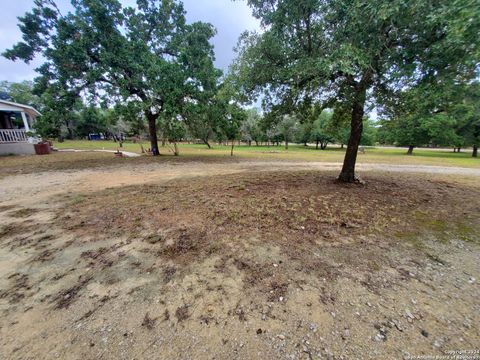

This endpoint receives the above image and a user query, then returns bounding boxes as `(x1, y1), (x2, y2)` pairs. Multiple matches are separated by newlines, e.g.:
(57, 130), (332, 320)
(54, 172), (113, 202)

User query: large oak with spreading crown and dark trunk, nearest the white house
(4, 0), (218, 155)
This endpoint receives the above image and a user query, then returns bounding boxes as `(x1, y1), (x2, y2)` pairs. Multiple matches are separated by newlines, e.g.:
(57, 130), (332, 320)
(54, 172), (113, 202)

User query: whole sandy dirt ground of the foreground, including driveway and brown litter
(0, 161), (480, 359)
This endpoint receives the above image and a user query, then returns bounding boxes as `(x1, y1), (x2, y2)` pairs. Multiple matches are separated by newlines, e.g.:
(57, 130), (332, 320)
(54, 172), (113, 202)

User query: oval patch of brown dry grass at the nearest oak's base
(60, 171), (478, 240)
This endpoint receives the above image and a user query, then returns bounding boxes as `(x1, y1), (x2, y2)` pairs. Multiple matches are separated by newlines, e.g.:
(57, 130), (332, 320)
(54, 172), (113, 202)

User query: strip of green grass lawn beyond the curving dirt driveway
(54, 140), (480, 168)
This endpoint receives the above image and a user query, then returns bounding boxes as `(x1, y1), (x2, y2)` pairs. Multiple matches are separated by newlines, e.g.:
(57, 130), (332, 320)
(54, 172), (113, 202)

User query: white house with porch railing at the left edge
(0, 100), (40, 155)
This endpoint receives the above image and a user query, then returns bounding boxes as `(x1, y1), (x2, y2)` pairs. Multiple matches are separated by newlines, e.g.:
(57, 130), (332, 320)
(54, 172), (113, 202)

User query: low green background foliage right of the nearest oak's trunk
(380, 79), (480, 156)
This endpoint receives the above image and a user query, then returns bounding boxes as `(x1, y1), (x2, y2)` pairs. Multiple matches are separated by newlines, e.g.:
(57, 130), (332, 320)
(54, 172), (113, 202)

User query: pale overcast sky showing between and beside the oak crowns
(0, 0), (259, 81)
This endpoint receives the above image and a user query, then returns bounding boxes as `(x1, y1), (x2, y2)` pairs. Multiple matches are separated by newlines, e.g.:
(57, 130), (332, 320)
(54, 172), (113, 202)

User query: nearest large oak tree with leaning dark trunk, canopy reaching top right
(232, 0), (480, 182)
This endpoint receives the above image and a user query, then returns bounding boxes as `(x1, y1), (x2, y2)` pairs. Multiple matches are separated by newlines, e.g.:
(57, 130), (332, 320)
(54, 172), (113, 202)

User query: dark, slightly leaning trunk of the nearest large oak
(338, 84), (367, 183)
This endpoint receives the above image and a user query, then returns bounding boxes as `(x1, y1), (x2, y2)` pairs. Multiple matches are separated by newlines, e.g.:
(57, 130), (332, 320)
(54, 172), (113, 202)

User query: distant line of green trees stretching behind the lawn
(0, 77), (480, 157)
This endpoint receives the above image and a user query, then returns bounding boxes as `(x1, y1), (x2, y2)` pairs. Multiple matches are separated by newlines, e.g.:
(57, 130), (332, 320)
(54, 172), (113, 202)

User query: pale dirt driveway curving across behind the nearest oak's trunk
(0, 161), (480, 204)
